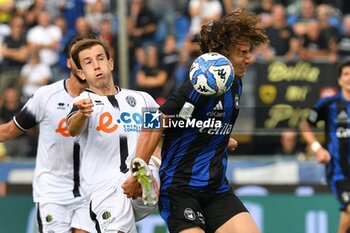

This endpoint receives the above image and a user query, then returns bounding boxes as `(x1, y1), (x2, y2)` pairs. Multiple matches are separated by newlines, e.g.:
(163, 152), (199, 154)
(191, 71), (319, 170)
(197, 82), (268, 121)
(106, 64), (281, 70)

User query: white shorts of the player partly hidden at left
(36, 199), (96, 233)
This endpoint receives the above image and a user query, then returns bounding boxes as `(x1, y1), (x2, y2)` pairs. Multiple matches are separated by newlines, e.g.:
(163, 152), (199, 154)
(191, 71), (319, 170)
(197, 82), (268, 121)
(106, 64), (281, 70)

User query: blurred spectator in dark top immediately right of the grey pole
(127, 0), (157, 46)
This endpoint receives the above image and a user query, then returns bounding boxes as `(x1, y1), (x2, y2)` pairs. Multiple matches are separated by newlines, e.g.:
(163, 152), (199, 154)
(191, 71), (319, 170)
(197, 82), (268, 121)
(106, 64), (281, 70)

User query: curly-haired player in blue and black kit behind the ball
(123, 10), (268, 233)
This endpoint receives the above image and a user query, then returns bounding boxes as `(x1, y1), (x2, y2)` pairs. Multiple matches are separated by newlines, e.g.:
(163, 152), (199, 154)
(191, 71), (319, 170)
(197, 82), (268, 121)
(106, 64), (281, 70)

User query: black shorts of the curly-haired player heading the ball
(159, 190), (248, 233)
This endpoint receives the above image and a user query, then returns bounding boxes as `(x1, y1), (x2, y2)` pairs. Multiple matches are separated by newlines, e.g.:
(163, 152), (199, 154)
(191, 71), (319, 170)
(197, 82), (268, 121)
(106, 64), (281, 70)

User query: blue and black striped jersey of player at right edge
(307, 93), (350, 181)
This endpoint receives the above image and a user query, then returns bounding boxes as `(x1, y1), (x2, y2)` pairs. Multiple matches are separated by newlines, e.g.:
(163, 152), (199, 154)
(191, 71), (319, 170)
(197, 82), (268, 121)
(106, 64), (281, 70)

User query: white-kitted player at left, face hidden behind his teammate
(0, 37), (96, 233)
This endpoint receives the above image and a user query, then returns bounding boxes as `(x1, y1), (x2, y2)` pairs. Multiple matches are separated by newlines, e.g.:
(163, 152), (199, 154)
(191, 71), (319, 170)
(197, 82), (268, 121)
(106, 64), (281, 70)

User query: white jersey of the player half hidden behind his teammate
(14, 80), (86, 204)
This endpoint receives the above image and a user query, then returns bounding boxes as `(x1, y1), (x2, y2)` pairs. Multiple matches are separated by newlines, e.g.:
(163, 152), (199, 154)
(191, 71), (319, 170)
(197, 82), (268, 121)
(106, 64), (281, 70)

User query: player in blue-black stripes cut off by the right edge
(300, 61), (350, 233)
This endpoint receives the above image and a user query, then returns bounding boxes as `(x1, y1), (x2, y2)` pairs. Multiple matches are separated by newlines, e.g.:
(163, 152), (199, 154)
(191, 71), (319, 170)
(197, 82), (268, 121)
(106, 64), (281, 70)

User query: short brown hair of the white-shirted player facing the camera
(72, 38), (110, 69)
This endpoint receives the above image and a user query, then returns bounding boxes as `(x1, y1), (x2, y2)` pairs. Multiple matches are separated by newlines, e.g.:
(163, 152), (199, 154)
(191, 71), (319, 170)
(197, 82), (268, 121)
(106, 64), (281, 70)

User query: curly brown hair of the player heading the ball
(199, 9), (269, 56)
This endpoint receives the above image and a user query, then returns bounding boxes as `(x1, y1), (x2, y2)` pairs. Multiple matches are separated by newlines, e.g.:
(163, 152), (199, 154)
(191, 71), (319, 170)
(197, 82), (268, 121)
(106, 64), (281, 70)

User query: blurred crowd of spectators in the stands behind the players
(0, 0), (350, 157)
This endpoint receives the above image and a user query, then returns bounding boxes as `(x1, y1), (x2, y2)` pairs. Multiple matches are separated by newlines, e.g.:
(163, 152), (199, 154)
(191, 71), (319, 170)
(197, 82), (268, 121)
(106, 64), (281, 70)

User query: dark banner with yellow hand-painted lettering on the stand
(254, 61), (338, 130)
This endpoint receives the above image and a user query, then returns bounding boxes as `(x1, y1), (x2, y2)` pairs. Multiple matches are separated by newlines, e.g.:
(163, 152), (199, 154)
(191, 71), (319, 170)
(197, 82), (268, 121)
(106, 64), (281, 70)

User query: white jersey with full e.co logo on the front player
(68, 89), (158, 199)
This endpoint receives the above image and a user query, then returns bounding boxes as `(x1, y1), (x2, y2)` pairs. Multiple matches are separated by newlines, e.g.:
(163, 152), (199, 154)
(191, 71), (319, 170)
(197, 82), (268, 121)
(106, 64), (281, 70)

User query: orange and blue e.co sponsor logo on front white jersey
(96, 112), (143, 133)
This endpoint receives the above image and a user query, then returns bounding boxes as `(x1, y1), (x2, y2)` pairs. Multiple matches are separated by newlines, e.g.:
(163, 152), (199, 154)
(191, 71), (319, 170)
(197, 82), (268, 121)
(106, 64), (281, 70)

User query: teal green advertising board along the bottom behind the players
(0, 194), (339, 233)
